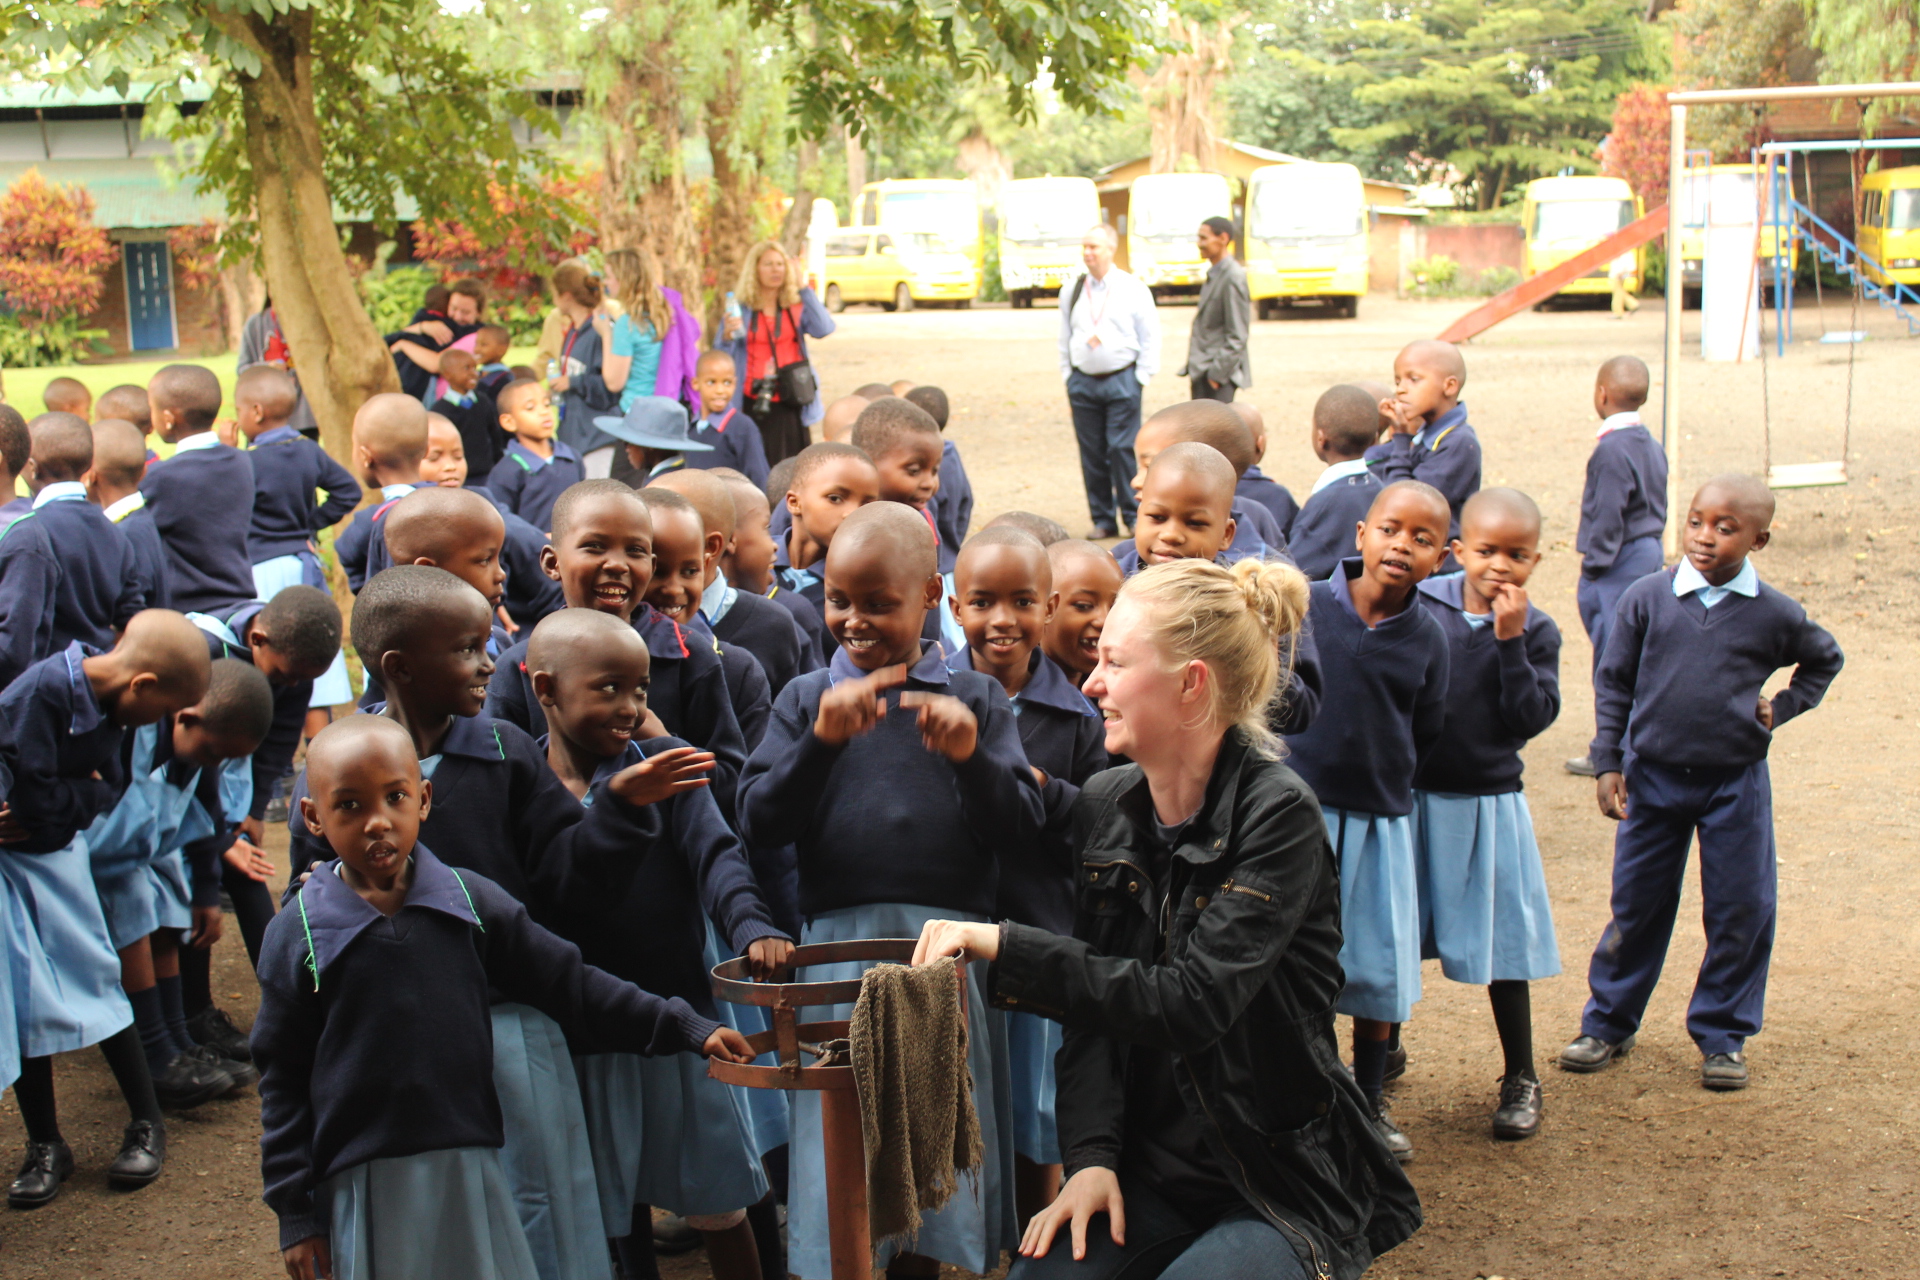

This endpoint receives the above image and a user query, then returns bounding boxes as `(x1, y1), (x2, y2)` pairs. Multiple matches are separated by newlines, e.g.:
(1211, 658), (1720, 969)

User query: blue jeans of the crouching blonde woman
(1006, 1176), (1308, 1280)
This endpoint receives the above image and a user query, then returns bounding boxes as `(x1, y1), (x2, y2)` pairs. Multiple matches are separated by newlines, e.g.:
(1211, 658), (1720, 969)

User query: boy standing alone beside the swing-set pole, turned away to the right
(1574, 355), (1667, 694)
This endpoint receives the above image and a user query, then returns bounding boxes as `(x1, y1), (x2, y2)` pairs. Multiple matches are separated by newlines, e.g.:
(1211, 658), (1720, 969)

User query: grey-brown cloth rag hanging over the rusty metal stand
(849, 956), (981, 1247)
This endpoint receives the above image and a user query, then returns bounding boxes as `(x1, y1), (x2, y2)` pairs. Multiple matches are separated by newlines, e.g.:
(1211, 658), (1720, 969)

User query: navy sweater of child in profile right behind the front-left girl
(286, 716), (660, 923)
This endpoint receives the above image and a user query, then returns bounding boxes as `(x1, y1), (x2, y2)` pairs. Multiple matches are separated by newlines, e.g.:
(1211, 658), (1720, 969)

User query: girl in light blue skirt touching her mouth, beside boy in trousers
(1413, 489), (1561, 1140)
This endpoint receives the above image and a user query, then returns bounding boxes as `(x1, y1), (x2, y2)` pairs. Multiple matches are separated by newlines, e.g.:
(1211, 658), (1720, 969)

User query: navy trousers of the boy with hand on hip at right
(1580, 756), (1778, 1054)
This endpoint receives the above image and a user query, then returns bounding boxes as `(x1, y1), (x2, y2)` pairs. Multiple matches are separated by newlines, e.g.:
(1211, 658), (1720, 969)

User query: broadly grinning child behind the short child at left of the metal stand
(486, 480), (747, 812)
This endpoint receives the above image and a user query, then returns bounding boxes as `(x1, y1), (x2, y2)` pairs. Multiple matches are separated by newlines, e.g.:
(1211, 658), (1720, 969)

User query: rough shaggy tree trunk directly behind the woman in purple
(601, 0), (701, 305)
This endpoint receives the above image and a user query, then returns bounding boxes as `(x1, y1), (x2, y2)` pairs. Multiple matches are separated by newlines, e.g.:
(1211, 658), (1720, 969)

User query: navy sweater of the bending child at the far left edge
(0, 641), (127, 854)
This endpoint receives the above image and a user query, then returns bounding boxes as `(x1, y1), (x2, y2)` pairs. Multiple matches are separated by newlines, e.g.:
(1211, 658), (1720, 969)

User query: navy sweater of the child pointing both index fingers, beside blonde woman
(739, 645), (1043, 917)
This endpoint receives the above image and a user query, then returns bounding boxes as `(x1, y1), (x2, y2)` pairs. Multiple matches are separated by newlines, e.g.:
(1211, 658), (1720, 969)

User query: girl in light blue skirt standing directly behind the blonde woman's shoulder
(1286, 480), (1448, 1159)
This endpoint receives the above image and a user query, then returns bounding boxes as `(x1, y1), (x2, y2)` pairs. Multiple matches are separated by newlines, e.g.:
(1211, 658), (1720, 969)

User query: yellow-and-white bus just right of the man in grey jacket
(1244, 161), (1367, 319)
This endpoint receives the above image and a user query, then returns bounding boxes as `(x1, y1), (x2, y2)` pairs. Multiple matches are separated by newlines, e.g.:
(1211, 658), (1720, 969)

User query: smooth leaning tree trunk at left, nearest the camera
(202, 4), (399, 461)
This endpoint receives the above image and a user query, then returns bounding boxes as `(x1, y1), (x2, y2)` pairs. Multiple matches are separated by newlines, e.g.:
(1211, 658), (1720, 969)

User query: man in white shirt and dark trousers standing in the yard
(1060, 223), (1160, 537)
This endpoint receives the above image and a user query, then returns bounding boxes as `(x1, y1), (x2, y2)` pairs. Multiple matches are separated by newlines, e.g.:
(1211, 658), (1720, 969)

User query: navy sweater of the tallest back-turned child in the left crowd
(140, 443), (253, 612)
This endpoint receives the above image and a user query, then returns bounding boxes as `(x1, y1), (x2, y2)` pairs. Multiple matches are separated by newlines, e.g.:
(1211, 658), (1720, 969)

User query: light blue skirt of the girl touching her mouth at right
(1413, 791), (1559, 986)
